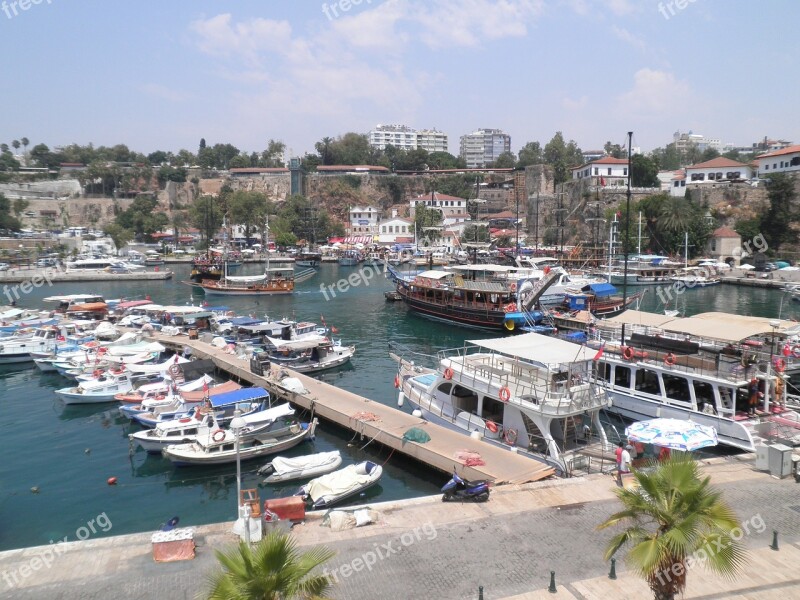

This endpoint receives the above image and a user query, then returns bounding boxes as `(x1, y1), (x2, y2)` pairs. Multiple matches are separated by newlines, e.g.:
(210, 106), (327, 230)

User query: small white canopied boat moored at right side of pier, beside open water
(261, 336), (356, 373)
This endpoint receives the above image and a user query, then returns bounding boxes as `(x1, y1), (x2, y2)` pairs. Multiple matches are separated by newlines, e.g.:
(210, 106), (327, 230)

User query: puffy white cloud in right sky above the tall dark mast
(617, 68), (692, 119)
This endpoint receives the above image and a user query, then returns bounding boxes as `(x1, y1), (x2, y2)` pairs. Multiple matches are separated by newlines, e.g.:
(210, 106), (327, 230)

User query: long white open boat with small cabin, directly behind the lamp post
(162, 416), (318, 467)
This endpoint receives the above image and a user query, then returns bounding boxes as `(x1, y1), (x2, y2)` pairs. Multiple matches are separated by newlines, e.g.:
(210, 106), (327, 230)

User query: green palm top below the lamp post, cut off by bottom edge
(208, 531), (335, 600)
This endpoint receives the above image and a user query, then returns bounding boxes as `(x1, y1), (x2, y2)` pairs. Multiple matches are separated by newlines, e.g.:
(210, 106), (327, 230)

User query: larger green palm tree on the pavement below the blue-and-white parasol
(598, 456), (745, 600)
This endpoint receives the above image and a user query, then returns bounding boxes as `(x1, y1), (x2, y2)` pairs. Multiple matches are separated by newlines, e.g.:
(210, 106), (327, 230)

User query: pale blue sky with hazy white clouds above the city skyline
(0, 0), (800, 156)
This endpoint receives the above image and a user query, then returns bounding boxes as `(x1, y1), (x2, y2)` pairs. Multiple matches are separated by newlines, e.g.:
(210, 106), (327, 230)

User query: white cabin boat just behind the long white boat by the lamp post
(128, 402), (294, 454)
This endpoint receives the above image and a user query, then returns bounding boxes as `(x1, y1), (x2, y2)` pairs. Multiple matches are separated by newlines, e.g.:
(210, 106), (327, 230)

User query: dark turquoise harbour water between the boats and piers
(0, 264), (800, 550)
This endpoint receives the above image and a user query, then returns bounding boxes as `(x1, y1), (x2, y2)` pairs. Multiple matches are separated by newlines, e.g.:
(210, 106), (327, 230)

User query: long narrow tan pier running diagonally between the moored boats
(152, 333), (555, 484)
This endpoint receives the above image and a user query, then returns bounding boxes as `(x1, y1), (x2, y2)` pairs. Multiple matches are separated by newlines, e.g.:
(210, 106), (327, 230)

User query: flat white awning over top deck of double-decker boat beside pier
(467, 333), (597, 366)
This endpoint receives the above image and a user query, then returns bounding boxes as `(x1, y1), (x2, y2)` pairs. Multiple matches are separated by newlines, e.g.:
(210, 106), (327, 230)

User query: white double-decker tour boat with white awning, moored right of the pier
(393, 333), (608, 473)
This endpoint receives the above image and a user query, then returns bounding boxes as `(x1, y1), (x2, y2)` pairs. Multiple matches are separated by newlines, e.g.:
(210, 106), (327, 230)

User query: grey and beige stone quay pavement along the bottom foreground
(0, 457), (800, 600)
